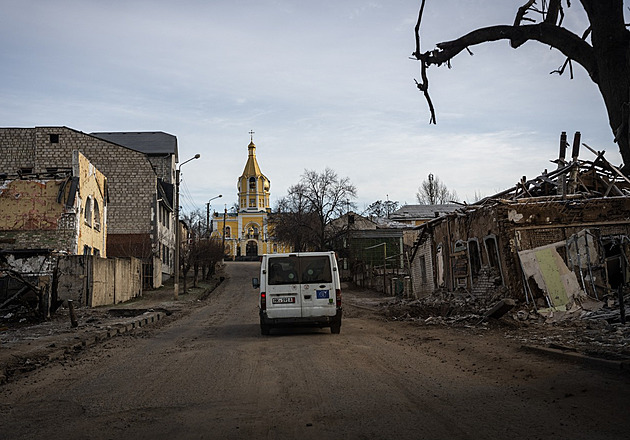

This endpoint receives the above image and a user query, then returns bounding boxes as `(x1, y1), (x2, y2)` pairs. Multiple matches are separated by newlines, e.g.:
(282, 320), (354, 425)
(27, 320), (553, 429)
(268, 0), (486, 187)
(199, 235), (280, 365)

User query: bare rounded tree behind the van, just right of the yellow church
(274, 168), (357, 250)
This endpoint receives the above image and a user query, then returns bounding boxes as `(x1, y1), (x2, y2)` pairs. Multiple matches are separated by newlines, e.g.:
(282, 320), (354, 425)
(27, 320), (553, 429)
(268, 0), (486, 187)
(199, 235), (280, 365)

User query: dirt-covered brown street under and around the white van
(0, 263), (630, 440)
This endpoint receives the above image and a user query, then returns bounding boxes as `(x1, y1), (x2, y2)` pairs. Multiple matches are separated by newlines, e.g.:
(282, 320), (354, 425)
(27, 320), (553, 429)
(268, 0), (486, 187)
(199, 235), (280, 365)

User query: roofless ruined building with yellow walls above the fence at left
(0, 150), (108, 257)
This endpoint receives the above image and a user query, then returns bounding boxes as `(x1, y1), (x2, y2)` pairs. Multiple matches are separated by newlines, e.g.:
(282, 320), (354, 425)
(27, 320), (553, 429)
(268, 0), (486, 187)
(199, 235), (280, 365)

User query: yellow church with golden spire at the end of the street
(212, 132), (291, 260)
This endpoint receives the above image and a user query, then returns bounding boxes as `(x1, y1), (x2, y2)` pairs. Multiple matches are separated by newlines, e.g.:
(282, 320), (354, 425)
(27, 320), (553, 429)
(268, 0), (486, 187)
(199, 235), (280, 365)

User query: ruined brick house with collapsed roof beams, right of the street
(411, 133), (630, 311)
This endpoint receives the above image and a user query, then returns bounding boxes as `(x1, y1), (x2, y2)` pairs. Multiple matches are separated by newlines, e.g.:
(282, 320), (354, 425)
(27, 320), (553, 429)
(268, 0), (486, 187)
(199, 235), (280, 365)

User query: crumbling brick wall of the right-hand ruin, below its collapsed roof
(413, 197), (630, 300)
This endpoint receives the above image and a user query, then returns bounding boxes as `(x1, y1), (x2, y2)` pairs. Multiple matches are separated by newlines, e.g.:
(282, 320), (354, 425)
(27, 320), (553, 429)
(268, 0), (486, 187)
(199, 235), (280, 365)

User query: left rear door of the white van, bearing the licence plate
(267, 255), (302, 319)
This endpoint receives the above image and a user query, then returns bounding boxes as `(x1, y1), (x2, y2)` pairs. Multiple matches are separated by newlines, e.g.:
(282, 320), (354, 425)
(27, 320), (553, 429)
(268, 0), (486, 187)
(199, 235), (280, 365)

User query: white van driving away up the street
(252, 252), (342, 335)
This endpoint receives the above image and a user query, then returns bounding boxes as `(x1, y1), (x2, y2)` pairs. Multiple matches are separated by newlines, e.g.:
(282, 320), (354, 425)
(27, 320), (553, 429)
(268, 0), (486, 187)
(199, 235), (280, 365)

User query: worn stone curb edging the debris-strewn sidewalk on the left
(0, 311), (166, 385)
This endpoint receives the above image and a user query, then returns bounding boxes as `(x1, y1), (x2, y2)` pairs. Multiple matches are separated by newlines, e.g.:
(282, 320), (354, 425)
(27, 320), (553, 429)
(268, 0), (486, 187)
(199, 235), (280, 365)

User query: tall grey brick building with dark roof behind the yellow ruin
(0, 127), (177, 288)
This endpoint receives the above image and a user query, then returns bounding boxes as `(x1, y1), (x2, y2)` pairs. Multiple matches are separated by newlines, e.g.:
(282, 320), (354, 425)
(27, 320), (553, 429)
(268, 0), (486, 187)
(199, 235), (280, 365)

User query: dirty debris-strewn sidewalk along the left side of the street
(0, 279), (225, 384)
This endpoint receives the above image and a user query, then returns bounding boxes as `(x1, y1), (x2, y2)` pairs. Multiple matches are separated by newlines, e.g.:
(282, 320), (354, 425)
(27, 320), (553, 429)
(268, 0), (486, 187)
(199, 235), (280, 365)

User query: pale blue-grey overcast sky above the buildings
(0, 0), (628, 211)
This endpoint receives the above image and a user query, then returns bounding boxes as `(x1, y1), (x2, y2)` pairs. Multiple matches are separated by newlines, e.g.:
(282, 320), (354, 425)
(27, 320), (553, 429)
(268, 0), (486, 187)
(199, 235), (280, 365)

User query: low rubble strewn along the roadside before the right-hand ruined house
(381, 292), (630, 360)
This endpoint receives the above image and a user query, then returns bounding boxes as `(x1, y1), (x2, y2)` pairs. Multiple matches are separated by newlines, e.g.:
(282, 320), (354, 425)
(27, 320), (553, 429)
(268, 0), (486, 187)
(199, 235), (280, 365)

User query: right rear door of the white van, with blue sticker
(299, 254), (337, 317)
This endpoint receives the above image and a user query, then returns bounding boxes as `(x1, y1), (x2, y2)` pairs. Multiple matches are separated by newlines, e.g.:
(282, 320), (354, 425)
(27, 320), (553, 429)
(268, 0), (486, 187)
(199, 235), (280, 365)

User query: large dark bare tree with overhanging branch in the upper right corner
(413, 0), (630, 169)
